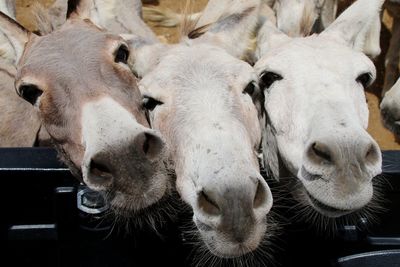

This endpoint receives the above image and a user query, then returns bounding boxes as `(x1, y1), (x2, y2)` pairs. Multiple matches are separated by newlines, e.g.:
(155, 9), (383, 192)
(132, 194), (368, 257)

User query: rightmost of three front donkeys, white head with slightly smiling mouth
(255, 0), (383, 227)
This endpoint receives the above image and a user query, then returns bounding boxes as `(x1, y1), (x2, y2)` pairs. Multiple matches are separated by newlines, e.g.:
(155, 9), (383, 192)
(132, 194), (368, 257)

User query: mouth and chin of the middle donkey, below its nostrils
(196, 220), (267, 259)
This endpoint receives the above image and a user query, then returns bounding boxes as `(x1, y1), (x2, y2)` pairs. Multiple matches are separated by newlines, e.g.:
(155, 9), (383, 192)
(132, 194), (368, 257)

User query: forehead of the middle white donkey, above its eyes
(141, 45), (256, 93)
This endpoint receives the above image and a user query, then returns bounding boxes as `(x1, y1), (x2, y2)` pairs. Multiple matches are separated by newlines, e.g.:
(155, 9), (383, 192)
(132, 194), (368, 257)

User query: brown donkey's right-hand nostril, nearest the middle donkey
(134, 131), (165, 161)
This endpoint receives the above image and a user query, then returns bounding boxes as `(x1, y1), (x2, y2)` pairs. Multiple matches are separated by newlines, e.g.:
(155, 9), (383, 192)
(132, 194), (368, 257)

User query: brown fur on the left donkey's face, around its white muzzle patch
(16, 19), (148, 166)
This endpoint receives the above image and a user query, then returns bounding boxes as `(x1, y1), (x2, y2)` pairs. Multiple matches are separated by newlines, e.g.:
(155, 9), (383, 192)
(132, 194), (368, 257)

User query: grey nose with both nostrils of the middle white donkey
(196, 176), (272, 243)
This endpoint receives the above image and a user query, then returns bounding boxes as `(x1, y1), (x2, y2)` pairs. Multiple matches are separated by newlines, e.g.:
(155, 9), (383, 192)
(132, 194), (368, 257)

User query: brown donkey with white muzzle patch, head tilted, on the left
(0, 3), (171, 217)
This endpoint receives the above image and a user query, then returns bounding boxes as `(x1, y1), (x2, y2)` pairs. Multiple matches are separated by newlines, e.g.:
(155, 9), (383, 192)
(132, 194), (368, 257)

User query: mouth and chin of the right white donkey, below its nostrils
(298, 166), (374, 218)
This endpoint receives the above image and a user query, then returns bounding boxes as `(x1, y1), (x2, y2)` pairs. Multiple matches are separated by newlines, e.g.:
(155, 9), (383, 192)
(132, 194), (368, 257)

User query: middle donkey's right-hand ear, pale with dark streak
(187, 0), (260, 58)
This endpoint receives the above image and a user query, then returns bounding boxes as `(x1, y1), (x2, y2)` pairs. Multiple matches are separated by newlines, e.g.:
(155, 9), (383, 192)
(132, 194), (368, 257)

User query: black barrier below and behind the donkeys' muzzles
(0, 148), (400, 267)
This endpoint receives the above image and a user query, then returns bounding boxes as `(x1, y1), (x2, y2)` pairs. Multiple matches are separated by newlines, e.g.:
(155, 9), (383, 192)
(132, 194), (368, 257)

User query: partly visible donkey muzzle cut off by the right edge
(380, 78), (400, 136)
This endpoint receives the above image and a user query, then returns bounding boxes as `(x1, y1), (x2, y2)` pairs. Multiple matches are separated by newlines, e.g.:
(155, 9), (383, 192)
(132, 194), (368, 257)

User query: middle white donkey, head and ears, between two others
(124, 0), (272, 258)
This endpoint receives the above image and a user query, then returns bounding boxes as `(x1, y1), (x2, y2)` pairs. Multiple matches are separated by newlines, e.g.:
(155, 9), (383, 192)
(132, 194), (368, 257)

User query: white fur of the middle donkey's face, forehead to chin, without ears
(140, 43), (272, 257)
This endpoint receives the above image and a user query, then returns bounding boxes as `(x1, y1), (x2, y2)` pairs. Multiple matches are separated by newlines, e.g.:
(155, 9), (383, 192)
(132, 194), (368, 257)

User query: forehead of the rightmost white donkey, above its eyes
(256, 35), (375, 79)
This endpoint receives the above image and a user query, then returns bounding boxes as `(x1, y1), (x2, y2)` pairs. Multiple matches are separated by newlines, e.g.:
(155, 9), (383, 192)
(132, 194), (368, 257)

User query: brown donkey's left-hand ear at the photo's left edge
(0, 12), (31, 64)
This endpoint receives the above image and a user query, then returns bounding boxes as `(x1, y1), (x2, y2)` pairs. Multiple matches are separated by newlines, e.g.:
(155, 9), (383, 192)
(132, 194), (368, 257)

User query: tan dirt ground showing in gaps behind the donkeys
(16, 0), (400, 150)
